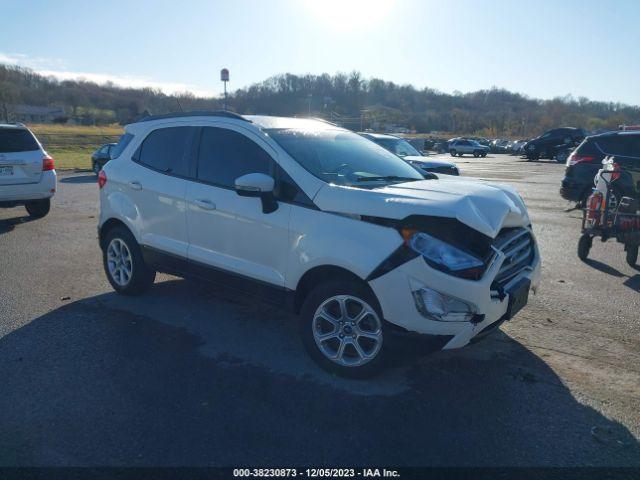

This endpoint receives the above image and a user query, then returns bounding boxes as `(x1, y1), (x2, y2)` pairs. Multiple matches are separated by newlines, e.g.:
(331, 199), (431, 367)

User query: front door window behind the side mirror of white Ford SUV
(198, 127), (273, 188)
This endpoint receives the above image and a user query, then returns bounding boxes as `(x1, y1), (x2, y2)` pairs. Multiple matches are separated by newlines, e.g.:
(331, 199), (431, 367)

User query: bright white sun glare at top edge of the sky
(305, 0), (395, 30)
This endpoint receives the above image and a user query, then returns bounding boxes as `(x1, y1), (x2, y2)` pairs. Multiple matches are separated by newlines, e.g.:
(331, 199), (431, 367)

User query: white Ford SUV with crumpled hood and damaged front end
(98, 112), (540, 377)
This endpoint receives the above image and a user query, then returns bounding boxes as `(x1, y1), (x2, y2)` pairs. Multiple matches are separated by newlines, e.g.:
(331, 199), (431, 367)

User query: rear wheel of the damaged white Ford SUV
(102, 227), (156, 295)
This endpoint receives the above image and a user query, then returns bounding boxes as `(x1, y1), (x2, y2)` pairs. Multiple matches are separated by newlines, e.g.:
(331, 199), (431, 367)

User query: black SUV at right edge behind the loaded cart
(560, 130), (640, 205)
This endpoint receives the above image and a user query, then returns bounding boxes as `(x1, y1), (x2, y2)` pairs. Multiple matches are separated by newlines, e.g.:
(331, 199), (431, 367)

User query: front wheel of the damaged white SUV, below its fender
(299, 281), (386, 378)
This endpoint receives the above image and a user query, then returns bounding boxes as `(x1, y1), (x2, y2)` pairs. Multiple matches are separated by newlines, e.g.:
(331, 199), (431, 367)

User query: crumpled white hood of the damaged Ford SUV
(314, 176), (530, 238)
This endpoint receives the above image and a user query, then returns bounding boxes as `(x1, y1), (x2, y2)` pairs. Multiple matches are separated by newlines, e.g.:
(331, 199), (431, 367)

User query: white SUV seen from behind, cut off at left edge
(0, 124), (56, 218)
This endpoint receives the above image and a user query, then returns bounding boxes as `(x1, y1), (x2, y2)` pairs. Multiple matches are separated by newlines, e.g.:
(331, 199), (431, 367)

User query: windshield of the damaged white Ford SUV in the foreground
(266, 129), (424, 188)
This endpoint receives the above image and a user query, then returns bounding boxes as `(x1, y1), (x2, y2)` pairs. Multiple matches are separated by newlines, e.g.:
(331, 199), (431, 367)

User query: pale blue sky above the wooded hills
(0, 0), (640, 105)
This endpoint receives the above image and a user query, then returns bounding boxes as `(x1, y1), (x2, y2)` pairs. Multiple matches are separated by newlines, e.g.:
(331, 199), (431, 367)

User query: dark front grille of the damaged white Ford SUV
(491, 228), (534, 290)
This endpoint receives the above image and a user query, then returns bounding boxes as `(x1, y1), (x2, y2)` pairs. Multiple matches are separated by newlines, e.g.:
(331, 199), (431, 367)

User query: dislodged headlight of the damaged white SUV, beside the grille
(408, 232), (484, 279)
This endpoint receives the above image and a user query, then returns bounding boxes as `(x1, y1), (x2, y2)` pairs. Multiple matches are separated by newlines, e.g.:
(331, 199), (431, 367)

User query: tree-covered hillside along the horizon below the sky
(0, 65), (640, 138)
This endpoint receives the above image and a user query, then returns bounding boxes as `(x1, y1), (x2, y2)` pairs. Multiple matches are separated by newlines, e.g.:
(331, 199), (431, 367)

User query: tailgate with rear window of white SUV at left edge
(0, 127), (44, 186)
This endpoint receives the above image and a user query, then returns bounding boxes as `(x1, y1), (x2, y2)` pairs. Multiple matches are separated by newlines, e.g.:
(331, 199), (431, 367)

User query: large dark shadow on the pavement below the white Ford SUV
(0, 280), (640, 466)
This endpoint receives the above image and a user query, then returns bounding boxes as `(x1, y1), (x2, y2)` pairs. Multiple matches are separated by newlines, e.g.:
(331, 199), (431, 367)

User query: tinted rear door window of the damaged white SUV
(137, 127), (195, 177)
